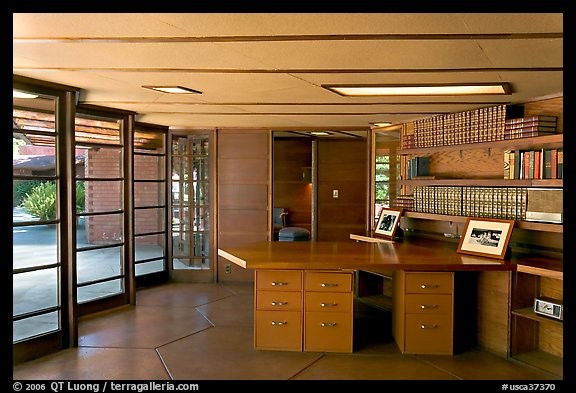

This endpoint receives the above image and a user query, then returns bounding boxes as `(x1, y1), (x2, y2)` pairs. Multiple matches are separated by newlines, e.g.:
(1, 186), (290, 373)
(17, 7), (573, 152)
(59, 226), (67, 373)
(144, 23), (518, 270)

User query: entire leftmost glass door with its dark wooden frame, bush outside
(12, 76), (77, 362)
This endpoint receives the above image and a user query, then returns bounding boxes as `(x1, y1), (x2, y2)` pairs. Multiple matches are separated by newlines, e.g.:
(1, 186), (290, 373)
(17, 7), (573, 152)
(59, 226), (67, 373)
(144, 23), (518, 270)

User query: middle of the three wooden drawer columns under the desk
(304, 272), (354, 352)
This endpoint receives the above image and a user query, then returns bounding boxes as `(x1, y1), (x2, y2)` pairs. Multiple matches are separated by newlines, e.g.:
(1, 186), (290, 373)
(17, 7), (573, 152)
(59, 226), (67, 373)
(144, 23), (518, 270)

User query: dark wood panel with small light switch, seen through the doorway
(317, 139), (368, 241)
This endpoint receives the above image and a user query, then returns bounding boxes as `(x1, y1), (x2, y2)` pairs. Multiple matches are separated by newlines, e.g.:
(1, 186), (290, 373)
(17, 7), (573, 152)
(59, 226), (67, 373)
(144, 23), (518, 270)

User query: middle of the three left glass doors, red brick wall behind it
(75, 108), (133, 315)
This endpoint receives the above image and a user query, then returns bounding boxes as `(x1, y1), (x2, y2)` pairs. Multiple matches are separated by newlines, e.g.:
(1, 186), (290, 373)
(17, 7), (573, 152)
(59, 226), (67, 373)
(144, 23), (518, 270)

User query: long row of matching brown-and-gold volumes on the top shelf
(402, 105), (506, 149)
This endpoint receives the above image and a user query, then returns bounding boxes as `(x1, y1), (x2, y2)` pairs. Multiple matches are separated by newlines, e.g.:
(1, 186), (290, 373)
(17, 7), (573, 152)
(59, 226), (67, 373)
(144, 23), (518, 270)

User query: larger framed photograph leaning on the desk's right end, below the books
(458, 217), (514, 259)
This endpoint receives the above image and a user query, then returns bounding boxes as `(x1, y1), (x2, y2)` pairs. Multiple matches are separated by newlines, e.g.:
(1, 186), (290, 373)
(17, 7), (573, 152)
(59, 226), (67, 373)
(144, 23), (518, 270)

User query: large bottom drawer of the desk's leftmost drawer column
(254, 311), (302, 351)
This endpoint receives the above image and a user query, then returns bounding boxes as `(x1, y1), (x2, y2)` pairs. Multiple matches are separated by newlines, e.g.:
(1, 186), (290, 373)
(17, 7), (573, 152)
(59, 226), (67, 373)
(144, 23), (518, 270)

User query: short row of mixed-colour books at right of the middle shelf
(504, 149), (564, 179)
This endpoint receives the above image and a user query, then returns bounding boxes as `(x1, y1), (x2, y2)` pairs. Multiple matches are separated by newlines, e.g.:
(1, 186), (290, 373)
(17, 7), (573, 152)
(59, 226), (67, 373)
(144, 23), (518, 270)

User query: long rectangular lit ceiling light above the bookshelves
(322, 83), (511, 96)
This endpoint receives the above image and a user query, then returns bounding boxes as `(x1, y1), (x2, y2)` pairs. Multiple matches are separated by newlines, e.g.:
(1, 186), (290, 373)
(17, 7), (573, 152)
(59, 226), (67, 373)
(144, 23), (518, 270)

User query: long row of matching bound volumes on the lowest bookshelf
(413, 186), (527, 220)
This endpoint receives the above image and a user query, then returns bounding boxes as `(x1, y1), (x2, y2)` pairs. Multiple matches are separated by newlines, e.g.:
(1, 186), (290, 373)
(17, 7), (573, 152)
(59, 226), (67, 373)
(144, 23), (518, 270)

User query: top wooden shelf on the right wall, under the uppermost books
(399, 134), (564, 155)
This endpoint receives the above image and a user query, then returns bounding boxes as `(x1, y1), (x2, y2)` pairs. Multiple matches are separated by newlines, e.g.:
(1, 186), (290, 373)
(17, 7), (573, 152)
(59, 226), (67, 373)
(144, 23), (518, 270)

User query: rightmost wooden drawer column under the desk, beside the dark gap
(392, 272), (454, 355)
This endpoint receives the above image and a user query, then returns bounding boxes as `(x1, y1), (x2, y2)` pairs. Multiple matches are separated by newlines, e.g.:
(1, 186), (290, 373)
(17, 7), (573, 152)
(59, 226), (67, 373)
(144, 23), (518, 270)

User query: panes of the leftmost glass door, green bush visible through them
(12, 92), (63, 343)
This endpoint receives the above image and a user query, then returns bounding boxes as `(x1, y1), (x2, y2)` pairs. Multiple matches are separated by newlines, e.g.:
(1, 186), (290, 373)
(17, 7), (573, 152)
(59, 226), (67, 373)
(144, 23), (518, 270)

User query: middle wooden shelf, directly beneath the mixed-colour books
(398, 179), (564, 188)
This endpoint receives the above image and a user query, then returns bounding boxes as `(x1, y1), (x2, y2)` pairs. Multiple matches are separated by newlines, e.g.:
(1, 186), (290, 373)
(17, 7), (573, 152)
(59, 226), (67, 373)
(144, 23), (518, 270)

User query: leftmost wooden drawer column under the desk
(254, 270), (303, 351)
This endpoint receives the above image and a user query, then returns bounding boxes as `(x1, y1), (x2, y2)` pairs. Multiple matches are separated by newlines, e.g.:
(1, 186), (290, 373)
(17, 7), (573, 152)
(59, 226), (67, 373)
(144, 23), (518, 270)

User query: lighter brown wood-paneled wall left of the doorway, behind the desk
(217, 129), (272, 282)
